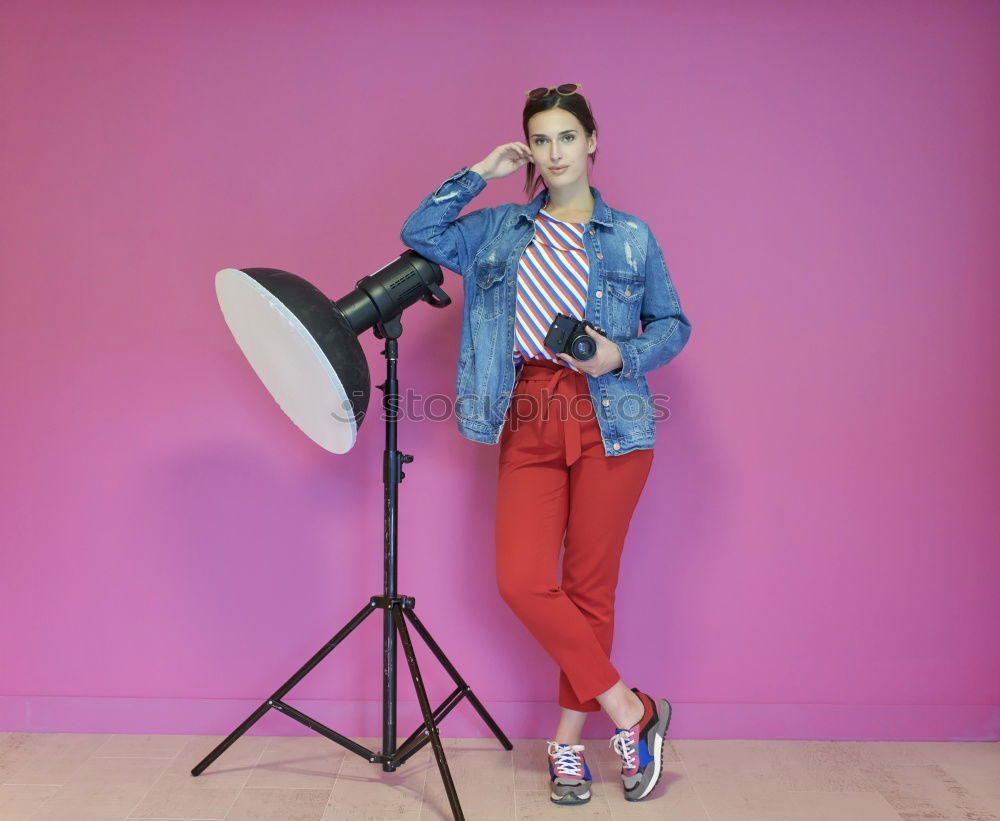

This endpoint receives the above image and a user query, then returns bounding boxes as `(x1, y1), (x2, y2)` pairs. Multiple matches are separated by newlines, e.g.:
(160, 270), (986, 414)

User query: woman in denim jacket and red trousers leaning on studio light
(401, 84), (691, 804)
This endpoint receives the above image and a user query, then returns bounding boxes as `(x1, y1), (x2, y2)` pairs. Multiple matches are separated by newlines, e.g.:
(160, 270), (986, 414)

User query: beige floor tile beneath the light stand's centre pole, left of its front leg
(323, 738), (428, 821)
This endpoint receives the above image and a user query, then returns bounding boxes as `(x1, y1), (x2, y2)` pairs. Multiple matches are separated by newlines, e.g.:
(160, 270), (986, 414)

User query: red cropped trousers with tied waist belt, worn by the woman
(496, 359), (653, 712)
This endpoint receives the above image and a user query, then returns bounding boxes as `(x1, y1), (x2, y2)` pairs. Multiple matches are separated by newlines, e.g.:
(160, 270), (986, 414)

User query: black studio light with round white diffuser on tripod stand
(191, 249), (513, 821)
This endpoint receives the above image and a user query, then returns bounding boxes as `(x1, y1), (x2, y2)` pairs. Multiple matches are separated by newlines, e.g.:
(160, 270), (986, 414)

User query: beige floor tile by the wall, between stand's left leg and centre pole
(246, 736), (355, 792)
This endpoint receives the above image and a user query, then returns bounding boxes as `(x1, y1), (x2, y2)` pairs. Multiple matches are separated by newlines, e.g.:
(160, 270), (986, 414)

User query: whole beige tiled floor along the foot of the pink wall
(0, 733), (1000, 821)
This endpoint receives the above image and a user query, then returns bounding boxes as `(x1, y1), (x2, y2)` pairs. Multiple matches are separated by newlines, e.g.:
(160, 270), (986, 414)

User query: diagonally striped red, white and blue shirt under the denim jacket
(513, 203), (590, 371)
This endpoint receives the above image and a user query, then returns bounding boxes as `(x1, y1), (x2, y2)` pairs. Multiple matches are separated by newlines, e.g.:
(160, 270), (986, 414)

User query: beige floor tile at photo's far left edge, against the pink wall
(0, 733), (109, 784)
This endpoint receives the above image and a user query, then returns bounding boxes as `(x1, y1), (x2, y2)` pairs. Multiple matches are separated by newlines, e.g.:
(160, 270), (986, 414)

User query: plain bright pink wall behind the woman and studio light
(0, 0), (1000, 739)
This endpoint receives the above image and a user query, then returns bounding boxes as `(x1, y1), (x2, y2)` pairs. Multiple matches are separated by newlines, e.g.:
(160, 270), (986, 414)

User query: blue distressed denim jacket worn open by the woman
(400, 167), (691, 456)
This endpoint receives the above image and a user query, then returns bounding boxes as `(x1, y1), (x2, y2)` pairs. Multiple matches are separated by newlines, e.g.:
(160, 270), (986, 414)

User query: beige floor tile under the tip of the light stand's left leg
(127, 735), (268, 819)
